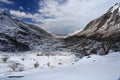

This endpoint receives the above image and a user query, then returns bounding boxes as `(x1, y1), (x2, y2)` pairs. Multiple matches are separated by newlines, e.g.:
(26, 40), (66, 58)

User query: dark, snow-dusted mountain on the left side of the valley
(0, 11), (61, 52)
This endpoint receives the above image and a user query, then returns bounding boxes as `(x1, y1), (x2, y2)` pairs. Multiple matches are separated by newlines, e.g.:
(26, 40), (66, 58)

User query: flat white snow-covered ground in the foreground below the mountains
(0, 52), (120, 80)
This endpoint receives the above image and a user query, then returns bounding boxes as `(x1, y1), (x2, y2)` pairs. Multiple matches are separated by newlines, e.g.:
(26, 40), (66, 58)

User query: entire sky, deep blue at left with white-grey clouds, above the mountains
(0, 0), (119, 35)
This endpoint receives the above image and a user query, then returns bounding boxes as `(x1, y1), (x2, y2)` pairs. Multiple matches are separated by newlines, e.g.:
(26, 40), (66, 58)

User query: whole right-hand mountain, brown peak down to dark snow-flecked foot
(64, 3), (120, 55)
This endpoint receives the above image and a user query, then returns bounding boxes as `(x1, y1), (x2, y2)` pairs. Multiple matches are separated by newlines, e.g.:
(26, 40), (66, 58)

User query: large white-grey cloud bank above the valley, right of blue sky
(39, 0), (118, 34)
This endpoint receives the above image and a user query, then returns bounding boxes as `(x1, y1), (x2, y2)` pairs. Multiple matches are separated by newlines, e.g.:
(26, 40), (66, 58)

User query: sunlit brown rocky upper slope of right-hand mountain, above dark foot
(77, 3), (120, 41)
